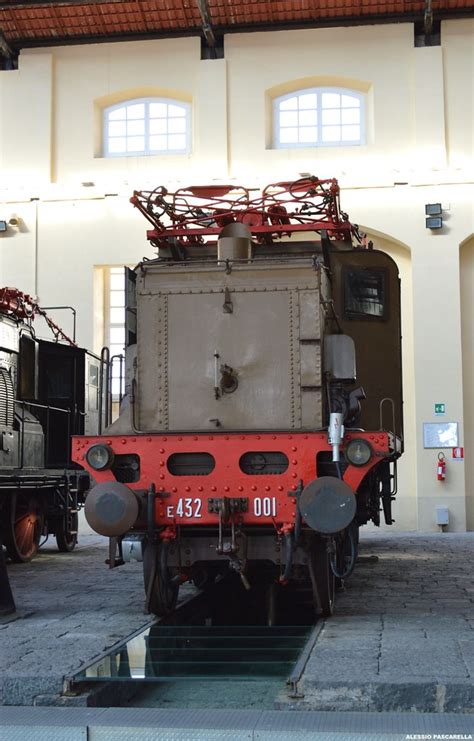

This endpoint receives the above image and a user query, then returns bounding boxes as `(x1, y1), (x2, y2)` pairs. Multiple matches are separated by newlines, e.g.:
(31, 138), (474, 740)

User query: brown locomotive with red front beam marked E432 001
(73, 177), (403, 615)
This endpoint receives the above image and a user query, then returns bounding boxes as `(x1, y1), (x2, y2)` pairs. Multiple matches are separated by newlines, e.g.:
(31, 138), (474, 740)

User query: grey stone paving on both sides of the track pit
(0, 531), (474, 712)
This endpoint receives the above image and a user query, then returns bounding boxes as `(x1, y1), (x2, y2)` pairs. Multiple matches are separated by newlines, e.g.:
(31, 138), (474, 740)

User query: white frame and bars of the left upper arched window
(102, 98), (191, 157)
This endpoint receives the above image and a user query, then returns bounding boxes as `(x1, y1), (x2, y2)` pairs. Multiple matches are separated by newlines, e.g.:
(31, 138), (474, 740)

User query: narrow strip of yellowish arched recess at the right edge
(459, 235), (474, 530)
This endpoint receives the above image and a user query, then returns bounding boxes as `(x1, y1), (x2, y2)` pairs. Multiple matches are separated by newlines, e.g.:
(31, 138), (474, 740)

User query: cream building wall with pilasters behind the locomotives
(0, 20), (474, 530)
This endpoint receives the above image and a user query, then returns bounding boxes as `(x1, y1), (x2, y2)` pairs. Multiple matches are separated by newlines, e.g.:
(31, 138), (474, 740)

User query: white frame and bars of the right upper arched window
(273, 86), (366, 149)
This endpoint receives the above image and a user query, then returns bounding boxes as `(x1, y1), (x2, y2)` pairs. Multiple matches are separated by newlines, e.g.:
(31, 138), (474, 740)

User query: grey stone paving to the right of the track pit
(279, 531), (474, 712)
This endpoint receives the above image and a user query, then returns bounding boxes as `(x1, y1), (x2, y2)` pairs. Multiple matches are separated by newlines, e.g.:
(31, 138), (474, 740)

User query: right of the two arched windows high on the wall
(273, 87), (365, 148)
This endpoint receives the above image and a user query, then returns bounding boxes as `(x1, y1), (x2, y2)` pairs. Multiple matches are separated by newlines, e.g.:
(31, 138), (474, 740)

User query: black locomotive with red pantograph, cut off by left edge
(0, 288), (104, 562)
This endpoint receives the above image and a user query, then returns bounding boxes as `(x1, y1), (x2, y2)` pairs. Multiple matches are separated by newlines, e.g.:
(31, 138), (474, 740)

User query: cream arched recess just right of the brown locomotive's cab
(361, 226), (418, 530)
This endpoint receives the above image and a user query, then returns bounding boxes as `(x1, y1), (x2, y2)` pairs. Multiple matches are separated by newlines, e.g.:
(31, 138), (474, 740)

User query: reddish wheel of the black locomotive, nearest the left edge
(4, 492), (44, 563)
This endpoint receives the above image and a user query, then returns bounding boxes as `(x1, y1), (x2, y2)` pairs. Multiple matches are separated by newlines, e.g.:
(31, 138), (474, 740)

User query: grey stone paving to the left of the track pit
(0, 535), (194, 705)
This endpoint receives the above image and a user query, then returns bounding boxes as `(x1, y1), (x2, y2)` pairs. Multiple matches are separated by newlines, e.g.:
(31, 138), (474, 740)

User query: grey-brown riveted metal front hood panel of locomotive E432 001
(136, 259), (327, 432)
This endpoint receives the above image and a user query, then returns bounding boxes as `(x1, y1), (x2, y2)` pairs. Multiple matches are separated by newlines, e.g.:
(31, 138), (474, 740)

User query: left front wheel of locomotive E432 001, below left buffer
(143, 541), (179, 617)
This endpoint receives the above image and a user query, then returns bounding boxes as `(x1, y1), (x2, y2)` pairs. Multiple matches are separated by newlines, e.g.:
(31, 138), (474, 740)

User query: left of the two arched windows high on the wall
(104, 98), (191, 157)
